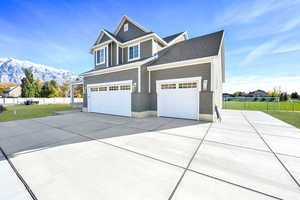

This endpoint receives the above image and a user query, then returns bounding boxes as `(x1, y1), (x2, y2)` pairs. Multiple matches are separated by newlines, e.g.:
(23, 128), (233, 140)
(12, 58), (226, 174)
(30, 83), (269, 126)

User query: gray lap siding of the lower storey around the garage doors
(83, 64), (213, 114)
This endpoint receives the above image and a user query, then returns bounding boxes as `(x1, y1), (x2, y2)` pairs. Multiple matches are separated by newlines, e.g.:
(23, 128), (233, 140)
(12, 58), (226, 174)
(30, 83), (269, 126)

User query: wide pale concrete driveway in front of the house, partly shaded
(0, 110), (300, 200)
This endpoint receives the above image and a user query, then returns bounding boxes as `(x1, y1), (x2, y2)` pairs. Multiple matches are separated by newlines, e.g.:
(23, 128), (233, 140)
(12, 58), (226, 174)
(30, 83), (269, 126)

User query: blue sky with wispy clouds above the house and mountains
(0, 0), (300, 92)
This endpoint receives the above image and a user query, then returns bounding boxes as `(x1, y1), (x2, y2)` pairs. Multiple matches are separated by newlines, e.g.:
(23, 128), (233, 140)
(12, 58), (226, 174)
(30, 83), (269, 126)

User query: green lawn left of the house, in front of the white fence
(0, 104), (77, 122)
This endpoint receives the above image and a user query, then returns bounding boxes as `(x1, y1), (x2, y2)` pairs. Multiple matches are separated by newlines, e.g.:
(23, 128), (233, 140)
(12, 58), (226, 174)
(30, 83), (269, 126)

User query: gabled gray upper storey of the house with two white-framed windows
(91, 16), (187, 69)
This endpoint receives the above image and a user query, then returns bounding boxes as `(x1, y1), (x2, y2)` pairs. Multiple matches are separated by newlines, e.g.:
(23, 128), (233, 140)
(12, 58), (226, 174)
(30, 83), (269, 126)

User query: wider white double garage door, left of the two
(88, 82), (132, 116)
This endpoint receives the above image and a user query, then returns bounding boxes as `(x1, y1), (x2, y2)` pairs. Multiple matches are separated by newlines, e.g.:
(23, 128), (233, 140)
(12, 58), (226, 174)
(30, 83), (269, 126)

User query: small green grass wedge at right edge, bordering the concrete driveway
(265, 111), (300, 128)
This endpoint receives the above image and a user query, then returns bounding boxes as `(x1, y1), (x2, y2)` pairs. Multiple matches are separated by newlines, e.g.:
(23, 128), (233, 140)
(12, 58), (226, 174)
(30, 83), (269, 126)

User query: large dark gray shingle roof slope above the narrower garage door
(150, 30), (224, 65)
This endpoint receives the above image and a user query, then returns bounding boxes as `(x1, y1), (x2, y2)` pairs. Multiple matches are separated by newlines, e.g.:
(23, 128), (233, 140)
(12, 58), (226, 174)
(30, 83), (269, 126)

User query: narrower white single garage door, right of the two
(156, 77), (201, 119)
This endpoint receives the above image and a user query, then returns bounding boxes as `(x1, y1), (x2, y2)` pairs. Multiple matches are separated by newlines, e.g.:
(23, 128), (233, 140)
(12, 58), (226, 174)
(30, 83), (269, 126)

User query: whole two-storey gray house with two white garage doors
(82, 16), (225, 121)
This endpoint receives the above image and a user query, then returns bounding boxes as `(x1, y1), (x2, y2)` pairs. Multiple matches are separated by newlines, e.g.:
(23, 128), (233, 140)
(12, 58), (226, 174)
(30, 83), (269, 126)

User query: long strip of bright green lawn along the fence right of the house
(223, 101), (300, 111)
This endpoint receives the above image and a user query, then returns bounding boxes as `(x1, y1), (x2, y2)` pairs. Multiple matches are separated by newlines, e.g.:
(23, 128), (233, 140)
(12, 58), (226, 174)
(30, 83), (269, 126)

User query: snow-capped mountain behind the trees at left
(0, 58), (78, 84)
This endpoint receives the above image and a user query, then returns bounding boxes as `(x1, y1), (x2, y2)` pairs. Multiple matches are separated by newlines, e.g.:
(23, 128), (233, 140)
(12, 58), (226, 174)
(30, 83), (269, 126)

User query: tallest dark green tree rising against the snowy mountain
(21, 69), (35, 97)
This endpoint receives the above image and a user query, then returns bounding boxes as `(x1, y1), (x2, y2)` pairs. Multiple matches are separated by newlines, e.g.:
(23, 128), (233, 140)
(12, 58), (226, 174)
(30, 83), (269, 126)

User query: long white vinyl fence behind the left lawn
(0, 97), (83, 105)
